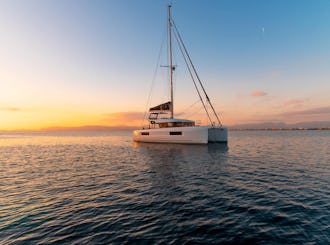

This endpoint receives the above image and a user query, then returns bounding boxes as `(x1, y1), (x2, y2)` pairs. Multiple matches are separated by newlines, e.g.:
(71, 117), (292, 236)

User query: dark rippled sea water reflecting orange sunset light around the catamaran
(0, 131), (330, 244)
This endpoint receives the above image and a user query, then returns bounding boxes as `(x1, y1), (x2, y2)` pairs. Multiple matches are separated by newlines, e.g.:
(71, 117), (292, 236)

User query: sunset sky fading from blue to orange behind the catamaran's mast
(0, 0), (330, 130)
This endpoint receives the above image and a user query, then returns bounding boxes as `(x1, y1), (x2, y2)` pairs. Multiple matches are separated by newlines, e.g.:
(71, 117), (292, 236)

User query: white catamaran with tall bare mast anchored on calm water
(133, 5), (228, 144)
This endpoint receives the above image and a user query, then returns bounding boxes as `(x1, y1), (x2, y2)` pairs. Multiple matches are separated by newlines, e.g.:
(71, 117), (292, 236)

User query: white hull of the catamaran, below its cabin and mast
(133, 126), (227, 144)
